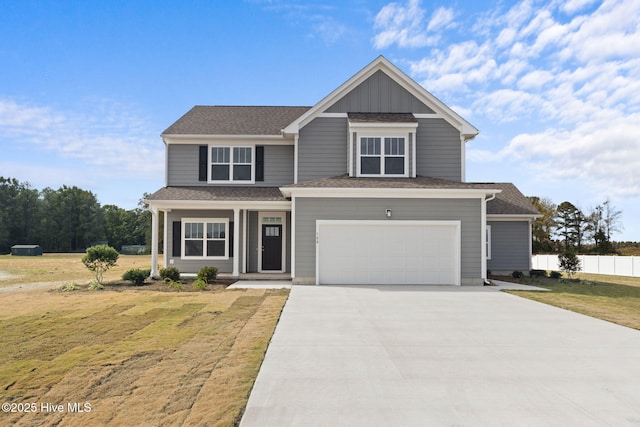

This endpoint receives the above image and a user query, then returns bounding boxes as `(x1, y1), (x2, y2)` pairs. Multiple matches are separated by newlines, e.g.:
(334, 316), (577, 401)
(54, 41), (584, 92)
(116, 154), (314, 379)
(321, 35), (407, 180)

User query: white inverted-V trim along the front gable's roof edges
(283, 55), (479, 140)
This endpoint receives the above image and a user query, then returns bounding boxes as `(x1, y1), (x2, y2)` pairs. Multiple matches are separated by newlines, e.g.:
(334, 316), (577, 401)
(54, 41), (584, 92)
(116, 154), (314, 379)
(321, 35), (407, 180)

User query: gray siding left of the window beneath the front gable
(298, 117), (348, 182)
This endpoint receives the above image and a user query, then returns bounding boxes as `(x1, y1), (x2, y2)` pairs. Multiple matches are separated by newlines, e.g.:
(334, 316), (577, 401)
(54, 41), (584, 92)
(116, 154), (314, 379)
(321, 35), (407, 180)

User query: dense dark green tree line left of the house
(0, 176), (151, 254)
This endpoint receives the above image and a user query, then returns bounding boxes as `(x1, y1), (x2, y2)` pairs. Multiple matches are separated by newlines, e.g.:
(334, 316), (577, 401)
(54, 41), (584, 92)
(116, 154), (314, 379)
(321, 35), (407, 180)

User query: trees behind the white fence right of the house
(529, 197), (638, 255)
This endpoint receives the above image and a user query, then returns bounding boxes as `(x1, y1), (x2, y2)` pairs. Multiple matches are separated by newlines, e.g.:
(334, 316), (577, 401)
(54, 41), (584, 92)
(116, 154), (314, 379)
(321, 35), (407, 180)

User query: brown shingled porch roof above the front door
(146, 187), (287, 202)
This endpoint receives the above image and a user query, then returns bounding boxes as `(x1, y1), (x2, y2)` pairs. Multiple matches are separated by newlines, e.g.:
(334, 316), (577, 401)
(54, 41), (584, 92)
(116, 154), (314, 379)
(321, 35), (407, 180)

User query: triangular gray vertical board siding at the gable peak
(325, 71), (433, 113)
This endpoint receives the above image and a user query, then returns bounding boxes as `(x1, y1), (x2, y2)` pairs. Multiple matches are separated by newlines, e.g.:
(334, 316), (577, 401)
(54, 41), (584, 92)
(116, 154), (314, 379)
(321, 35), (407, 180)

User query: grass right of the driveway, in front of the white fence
(509, 273), (640, 329)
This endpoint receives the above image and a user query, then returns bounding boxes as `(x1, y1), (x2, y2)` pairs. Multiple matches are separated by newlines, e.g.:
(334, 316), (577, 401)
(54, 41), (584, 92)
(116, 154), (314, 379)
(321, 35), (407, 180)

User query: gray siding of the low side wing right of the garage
(487, 221), (531, 273)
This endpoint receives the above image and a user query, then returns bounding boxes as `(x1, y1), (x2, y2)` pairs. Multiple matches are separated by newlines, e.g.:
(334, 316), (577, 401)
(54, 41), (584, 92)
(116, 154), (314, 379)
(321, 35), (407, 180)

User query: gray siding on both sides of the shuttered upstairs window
(167, 144), (294, 187)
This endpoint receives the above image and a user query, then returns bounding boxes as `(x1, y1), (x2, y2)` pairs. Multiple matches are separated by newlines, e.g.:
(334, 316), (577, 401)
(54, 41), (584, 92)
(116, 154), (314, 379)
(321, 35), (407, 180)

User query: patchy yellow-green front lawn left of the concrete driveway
(0, 289), (288, 426)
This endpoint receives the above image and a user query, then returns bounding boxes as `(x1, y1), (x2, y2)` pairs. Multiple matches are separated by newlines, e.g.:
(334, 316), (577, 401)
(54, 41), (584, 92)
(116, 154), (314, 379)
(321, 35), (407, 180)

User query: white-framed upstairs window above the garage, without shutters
(360, 137), (406, 176)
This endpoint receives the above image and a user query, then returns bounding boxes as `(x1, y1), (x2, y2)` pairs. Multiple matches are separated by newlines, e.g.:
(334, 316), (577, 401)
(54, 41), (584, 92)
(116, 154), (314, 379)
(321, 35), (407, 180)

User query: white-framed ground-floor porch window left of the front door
(182, 219), (229, 259)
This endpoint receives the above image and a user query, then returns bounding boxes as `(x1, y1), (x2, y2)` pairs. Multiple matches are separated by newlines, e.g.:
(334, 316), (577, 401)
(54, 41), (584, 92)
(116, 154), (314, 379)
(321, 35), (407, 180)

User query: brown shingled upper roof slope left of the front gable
(162, 105), (311, 135)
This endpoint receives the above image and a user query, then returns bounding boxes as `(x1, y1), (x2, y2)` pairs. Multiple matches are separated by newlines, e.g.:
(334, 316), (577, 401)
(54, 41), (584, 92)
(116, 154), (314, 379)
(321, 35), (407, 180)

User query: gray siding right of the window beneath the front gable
(416, 119), (462, 181)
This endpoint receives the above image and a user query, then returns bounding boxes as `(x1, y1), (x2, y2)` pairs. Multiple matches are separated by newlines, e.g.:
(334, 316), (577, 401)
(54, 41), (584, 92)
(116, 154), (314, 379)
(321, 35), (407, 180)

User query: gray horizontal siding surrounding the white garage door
(294, 197), (483, 285)
